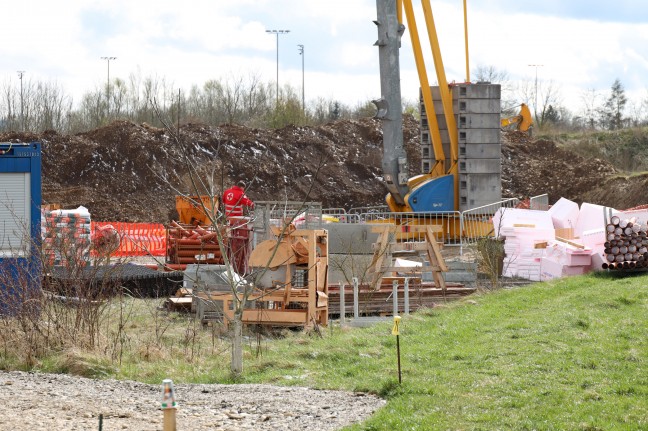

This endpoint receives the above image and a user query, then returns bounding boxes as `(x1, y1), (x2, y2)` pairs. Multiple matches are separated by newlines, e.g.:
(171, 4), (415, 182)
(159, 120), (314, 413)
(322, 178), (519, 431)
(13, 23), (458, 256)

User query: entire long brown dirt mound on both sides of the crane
(0, 121), (648, 223)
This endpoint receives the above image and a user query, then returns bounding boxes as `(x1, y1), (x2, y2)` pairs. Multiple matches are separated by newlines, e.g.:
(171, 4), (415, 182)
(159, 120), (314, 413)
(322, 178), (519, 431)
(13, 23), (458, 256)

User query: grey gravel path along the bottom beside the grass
(0, 371), (385, 431)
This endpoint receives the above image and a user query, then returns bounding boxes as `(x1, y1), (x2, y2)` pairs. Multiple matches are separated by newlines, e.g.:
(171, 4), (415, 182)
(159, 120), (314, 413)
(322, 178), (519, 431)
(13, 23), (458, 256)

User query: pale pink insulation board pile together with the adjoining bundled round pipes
(493, 198), (648, 281)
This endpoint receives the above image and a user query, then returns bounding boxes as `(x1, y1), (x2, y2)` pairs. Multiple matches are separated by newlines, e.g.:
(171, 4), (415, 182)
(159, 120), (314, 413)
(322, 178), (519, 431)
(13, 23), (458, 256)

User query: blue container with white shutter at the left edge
(0, 142), (42, 314)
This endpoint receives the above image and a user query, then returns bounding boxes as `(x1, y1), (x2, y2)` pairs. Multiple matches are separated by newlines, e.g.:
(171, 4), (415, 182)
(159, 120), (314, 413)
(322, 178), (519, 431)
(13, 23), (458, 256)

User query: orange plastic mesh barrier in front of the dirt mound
(91, 221), (166, 257)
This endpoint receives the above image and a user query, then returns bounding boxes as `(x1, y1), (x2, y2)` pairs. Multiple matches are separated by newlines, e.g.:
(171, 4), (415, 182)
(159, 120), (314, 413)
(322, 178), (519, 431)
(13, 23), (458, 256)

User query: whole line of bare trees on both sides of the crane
(0, 66), (648, 134)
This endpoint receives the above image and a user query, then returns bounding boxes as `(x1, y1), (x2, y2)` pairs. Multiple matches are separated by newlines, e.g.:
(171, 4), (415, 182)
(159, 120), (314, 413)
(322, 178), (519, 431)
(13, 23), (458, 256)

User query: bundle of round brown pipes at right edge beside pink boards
(602, 216), (648, 270)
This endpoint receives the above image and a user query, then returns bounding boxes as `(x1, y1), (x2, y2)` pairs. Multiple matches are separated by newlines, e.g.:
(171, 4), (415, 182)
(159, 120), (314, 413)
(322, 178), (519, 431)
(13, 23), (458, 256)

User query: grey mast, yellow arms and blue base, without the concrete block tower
(373, 0), (468, 212)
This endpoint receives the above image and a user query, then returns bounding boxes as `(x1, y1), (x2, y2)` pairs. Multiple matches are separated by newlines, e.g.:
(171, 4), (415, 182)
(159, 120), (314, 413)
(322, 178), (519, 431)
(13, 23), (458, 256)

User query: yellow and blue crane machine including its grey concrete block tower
(374, 0), (506, 219)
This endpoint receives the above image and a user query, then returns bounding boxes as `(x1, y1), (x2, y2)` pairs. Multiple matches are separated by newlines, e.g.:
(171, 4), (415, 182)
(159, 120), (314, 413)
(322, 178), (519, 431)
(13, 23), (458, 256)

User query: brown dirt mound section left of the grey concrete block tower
(0, 117), (420, 222)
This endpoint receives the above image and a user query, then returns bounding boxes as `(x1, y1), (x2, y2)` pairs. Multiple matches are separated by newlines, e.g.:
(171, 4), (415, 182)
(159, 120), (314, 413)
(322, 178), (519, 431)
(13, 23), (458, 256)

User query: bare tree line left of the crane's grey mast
(0, 74), (380, 134)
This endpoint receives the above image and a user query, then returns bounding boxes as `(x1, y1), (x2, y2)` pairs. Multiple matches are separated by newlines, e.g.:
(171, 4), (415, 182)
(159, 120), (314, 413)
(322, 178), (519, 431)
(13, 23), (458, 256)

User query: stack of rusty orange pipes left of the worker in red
(166, 222), (225, 265)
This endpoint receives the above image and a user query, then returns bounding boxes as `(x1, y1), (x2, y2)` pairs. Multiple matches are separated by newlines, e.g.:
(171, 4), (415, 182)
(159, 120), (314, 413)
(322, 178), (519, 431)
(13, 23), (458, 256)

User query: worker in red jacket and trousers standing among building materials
(223, 181), (254, 275)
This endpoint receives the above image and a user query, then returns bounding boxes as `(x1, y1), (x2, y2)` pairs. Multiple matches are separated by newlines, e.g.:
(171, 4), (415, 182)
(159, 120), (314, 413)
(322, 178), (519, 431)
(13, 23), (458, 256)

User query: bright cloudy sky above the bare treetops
(0, 0), (648, 113)
